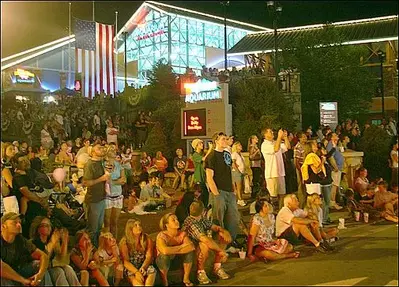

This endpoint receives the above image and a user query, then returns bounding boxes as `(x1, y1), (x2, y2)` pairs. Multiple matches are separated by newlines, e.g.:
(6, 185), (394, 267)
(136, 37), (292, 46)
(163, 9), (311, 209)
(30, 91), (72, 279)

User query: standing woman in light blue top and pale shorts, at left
(104, 149), (126, 238)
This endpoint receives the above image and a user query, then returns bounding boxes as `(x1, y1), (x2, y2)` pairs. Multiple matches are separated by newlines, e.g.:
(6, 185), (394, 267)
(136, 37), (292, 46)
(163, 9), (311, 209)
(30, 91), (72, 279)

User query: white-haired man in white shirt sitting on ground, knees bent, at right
(276, 194), (330, 253)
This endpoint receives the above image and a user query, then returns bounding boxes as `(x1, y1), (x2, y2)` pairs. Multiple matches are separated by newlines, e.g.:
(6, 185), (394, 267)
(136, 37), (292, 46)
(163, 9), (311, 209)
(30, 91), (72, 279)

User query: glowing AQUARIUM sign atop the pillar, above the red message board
(184, 79), (222, 103)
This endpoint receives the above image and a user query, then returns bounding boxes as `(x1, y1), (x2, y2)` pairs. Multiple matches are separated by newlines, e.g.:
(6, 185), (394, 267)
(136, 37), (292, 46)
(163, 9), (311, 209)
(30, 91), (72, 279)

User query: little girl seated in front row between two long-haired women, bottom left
(97, 232), (123, 286)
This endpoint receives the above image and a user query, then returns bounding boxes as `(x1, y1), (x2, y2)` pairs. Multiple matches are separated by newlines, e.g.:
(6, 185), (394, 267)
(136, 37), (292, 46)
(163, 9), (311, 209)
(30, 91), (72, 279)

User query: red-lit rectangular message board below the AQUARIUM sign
(183, 109), (206, 137)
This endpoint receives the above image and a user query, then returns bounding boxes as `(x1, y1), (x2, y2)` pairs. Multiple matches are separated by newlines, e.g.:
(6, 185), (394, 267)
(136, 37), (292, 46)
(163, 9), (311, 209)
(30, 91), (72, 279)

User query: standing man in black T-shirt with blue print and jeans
(205, 132), (240, 250)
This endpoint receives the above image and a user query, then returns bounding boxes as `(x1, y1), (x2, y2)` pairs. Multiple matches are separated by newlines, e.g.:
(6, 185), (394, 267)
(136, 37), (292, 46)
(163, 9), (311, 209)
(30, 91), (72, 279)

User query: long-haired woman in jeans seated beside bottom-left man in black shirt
(29, 216), (81, 286)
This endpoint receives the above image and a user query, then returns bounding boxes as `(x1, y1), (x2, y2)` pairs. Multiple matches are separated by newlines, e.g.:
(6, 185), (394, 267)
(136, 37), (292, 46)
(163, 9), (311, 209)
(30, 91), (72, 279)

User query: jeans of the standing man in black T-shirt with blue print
(211, 189), (240, 241)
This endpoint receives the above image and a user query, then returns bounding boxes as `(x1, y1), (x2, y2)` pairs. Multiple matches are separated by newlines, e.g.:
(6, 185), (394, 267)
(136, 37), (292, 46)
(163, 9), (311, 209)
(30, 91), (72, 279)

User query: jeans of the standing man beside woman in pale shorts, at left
(87, 200), (105, 247)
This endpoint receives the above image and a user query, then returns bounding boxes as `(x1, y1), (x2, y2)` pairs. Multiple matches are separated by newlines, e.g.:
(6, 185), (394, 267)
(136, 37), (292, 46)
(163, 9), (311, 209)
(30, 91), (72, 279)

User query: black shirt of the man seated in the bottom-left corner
(0, 234), (36, 272)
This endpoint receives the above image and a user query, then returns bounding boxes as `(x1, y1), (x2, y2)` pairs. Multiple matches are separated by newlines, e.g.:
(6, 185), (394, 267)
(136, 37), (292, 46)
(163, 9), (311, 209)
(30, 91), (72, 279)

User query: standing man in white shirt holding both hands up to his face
(261, 127), (291, 209)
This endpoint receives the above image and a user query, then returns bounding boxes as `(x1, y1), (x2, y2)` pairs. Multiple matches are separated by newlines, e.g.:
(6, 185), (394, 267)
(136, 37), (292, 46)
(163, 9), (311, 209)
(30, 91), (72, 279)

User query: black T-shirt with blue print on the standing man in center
(205, 150), (233, 192)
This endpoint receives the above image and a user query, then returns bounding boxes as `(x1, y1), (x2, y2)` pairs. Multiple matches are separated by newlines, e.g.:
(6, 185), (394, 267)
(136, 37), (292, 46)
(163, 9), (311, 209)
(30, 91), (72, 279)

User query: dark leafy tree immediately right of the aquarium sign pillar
(229, 77), (295, 148)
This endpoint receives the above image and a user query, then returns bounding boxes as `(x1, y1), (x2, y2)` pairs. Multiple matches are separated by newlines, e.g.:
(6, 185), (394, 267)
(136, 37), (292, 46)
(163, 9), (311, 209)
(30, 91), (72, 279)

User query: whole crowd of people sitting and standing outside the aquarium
(1, 111), (398, 286)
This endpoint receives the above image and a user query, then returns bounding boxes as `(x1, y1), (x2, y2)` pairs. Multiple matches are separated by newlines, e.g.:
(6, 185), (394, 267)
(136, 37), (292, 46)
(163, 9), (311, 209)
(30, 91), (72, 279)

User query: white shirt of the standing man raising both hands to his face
(261, 140), (287, 179)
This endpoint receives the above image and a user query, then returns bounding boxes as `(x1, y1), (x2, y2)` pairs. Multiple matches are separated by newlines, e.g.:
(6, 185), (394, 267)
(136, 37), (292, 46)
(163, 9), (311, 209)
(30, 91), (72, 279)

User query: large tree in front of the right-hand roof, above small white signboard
(281, 25), (376, 126)
